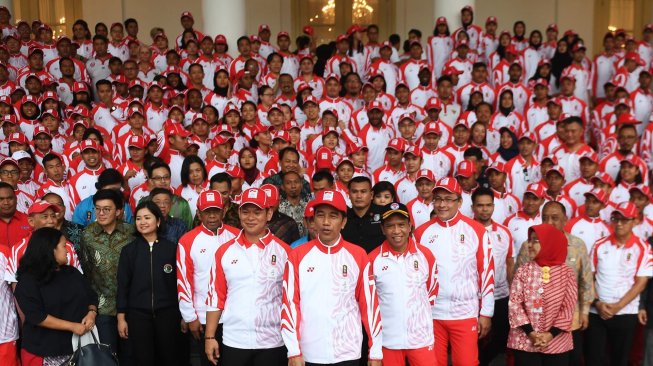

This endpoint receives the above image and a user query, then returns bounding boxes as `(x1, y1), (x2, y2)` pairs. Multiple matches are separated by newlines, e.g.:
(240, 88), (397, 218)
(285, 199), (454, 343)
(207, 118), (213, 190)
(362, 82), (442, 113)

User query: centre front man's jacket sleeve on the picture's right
(356, 256), (383, 360)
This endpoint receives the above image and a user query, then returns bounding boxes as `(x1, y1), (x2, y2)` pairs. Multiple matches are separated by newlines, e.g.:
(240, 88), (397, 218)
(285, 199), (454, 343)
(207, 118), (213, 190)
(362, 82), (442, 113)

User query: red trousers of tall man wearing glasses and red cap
(433, 318), (478, 366)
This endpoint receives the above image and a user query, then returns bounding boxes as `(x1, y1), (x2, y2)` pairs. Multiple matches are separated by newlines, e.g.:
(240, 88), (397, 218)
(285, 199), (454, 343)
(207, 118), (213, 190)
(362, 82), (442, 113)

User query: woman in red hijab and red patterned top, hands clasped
(508, 224), (578, 366)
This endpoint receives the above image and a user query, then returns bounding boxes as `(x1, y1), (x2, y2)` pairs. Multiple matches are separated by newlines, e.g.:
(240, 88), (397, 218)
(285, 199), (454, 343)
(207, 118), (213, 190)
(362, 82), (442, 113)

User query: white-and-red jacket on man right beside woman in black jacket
(177, 224), (240, 324)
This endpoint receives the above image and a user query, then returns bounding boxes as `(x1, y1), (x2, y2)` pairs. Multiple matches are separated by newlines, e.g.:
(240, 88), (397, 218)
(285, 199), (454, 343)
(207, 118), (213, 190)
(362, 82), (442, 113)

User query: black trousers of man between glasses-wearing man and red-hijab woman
(478, 297), (510, 366)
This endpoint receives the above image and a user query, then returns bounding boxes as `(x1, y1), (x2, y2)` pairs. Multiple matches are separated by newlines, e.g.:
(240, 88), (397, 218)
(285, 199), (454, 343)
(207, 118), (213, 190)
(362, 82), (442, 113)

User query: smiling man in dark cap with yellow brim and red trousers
(369, 202), (439, 366)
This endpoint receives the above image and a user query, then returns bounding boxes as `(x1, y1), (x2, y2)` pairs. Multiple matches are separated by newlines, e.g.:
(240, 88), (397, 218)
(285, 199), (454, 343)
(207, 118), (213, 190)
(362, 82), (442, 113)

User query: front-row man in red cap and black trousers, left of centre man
(204, 188), (290, 366)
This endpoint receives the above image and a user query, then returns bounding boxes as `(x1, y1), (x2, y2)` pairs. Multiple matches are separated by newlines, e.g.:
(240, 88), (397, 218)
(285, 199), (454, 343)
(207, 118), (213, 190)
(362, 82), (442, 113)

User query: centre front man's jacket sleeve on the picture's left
(281, 252), (302, 358)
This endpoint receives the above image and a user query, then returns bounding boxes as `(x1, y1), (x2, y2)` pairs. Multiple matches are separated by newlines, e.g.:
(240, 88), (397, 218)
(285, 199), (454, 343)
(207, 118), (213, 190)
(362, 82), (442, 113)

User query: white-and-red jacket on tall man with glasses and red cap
(415, 212), (494, 320)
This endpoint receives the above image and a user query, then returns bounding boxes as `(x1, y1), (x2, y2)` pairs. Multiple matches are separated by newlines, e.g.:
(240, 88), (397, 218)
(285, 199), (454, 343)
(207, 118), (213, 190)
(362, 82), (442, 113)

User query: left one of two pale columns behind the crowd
(202, 0), (245, 45)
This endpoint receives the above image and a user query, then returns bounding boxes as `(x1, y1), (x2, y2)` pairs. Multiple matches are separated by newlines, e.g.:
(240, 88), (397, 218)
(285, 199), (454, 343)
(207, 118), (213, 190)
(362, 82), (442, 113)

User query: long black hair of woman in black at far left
(16, 227), (63, 284)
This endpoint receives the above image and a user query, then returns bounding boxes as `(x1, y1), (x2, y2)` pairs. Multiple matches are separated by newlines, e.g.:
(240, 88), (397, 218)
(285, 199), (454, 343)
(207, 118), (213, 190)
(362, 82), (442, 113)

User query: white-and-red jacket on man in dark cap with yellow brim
(370, 238), (438, 350)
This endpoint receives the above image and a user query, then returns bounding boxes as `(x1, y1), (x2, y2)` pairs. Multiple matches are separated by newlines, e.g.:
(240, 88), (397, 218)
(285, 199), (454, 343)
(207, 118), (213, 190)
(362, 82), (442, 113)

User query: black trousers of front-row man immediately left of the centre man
(220, 345), (288, 366)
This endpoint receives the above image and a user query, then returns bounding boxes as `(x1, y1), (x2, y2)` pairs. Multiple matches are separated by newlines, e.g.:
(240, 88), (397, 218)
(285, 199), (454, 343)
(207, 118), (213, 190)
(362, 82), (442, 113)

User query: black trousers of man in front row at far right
(585, 314), (637, 366)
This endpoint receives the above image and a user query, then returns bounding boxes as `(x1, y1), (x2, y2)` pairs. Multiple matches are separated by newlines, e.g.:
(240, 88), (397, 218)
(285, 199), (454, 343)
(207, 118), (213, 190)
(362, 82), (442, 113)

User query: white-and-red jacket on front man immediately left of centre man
(206, 231), (290, 349)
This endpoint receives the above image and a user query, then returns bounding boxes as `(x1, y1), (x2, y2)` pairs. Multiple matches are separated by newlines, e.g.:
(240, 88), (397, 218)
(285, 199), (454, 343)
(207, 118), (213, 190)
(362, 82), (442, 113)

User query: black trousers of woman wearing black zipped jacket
(127, 307), (181, 366)
